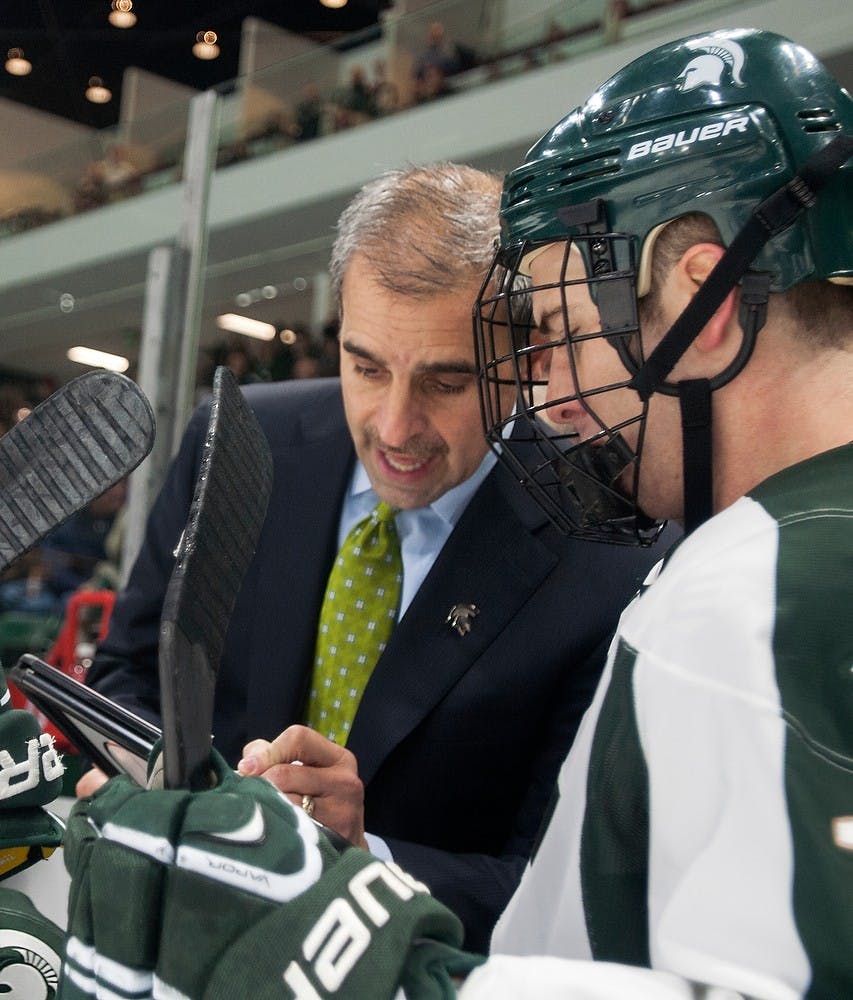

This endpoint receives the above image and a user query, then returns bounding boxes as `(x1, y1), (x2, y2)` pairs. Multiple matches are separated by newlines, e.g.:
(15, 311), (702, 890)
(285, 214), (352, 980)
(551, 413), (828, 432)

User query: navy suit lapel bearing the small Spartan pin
(347, 467), (556, 784)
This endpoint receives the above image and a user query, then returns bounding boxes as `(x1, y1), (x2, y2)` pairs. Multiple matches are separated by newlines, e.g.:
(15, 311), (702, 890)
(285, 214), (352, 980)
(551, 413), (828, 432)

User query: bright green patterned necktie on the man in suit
(308, 501), (403, 746)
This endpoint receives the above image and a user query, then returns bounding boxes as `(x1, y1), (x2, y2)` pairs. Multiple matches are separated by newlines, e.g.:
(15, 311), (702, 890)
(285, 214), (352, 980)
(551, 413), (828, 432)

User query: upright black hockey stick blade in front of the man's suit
(159, 367), (272, 789)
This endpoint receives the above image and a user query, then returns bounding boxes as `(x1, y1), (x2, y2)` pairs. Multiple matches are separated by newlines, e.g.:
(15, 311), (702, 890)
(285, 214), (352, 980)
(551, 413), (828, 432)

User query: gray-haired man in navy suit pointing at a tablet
(85, 164), (662, 948)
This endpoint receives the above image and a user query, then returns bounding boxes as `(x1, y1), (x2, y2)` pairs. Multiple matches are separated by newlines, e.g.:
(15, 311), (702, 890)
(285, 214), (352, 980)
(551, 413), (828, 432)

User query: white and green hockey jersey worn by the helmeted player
(492, 446), (853, 1000)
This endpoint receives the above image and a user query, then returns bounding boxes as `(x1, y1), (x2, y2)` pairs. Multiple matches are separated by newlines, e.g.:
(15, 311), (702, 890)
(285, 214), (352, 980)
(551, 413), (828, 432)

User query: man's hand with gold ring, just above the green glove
(237, 726), (368, 850)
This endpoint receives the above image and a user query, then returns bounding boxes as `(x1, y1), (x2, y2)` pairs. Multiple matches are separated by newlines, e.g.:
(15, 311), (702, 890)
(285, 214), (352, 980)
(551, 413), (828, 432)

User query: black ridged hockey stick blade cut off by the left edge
(0, 371), (154, 572)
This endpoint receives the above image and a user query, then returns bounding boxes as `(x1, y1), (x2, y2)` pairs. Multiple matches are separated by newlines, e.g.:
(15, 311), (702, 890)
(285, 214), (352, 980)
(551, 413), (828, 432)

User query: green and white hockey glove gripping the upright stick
(59, 753), (480, 1000)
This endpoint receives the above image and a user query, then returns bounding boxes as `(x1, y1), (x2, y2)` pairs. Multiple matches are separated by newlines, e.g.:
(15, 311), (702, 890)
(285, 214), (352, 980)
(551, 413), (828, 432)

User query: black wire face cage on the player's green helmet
(474, 233), (663, 545)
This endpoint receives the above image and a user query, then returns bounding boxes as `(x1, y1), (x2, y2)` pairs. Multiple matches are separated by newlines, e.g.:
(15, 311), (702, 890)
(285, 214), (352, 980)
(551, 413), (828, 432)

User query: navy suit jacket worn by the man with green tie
(89, 379), (662, 949)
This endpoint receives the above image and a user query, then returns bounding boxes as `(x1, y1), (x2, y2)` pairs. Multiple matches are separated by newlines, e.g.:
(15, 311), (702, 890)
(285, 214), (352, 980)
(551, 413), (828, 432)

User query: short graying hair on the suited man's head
(329, 163), (502, 309)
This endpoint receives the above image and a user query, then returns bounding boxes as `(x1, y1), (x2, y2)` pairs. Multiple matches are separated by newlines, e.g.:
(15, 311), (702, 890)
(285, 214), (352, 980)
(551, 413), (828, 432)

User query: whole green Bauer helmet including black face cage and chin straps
(474, 29), (853, 544)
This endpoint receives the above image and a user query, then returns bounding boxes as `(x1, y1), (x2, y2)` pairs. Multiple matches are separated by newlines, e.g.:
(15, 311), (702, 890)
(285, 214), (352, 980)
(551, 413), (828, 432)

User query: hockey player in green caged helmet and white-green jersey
(463, 30), (853, 1000)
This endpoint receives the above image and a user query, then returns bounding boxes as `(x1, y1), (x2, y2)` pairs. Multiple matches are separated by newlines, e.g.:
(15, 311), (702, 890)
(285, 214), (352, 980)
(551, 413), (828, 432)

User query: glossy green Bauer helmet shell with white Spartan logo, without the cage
(501, 29), (853, 295)
